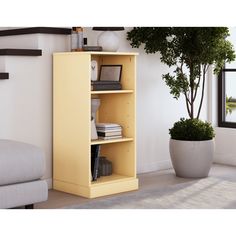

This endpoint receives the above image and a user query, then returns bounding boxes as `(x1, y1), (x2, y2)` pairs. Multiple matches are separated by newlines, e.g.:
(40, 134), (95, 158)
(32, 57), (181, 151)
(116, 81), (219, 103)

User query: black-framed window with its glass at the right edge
(218, 62), (236, 128)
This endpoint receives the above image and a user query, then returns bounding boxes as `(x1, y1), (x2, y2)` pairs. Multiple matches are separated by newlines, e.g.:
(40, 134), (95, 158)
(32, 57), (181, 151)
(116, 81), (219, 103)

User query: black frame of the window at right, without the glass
(218, 67), (236, 128)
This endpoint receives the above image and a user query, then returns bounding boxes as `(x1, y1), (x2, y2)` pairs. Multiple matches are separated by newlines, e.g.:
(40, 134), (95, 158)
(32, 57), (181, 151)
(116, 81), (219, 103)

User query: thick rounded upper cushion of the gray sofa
(0, 139), (44, 186)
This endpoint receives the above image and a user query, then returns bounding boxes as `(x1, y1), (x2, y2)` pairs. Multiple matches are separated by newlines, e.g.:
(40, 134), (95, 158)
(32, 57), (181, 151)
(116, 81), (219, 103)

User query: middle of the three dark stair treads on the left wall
(0, 48), (42, 56)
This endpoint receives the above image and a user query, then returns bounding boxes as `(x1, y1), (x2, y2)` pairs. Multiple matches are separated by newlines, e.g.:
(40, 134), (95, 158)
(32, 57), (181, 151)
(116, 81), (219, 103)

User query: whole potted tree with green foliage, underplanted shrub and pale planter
(127, 27), (235, 178)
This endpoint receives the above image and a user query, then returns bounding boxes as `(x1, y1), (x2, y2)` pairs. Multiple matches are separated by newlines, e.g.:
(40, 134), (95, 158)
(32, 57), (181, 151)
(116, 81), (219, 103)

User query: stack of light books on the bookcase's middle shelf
(96, 123), (122, 140)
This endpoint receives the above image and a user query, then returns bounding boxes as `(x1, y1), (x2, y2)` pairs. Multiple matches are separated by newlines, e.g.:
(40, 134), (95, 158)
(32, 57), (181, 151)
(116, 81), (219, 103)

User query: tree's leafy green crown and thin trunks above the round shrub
(127, 27), (235, 119)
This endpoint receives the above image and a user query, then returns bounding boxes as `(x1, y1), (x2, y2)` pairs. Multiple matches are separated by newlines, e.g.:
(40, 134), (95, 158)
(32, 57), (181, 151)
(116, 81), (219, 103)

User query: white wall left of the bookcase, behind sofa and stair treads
(0, 34), (70, 187)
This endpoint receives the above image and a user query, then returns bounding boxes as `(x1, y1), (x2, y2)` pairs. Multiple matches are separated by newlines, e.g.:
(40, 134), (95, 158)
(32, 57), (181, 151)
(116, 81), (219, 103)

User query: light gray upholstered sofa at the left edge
(0, 139), (48, 209)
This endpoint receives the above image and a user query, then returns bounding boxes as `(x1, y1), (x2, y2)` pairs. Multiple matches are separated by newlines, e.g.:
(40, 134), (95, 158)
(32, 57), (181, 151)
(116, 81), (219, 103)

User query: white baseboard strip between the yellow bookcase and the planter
(137, 160), (172, 174)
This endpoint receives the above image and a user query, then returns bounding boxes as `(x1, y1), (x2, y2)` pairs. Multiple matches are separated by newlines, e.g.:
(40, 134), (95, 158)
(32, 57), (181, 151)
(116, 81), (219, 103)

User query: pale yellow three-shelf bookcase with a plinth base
(53, 52), (138, 198)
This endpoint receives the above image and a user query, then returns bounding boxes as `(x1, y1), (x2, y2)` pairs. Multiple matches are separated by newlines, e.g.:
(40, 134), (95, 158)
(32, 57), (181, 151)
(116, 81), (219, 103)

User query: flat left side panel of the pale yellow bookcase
(53, 53), (91, 186)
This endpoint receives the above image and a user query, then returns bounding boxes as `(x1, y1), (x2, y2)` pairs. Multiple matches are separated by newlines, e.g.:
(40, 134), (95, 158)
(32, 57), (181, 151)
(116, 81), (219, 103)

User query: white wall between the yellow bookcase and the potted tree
(85, 28), (207, 173)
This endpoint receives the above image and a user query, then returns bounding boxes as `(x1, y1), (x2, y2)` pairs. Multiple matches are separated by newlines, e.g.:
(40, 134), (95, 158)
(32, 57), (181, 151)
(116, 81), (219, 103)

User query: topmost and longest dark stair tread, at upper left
(0, 27), (71, 36)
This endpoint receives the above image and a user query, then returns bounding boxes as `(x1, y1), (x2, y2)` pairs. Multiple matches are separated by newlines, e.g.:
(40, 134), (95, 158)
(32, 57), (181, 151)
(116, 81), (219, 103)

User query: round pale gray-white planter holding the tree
(169, 139), (215, 178)
